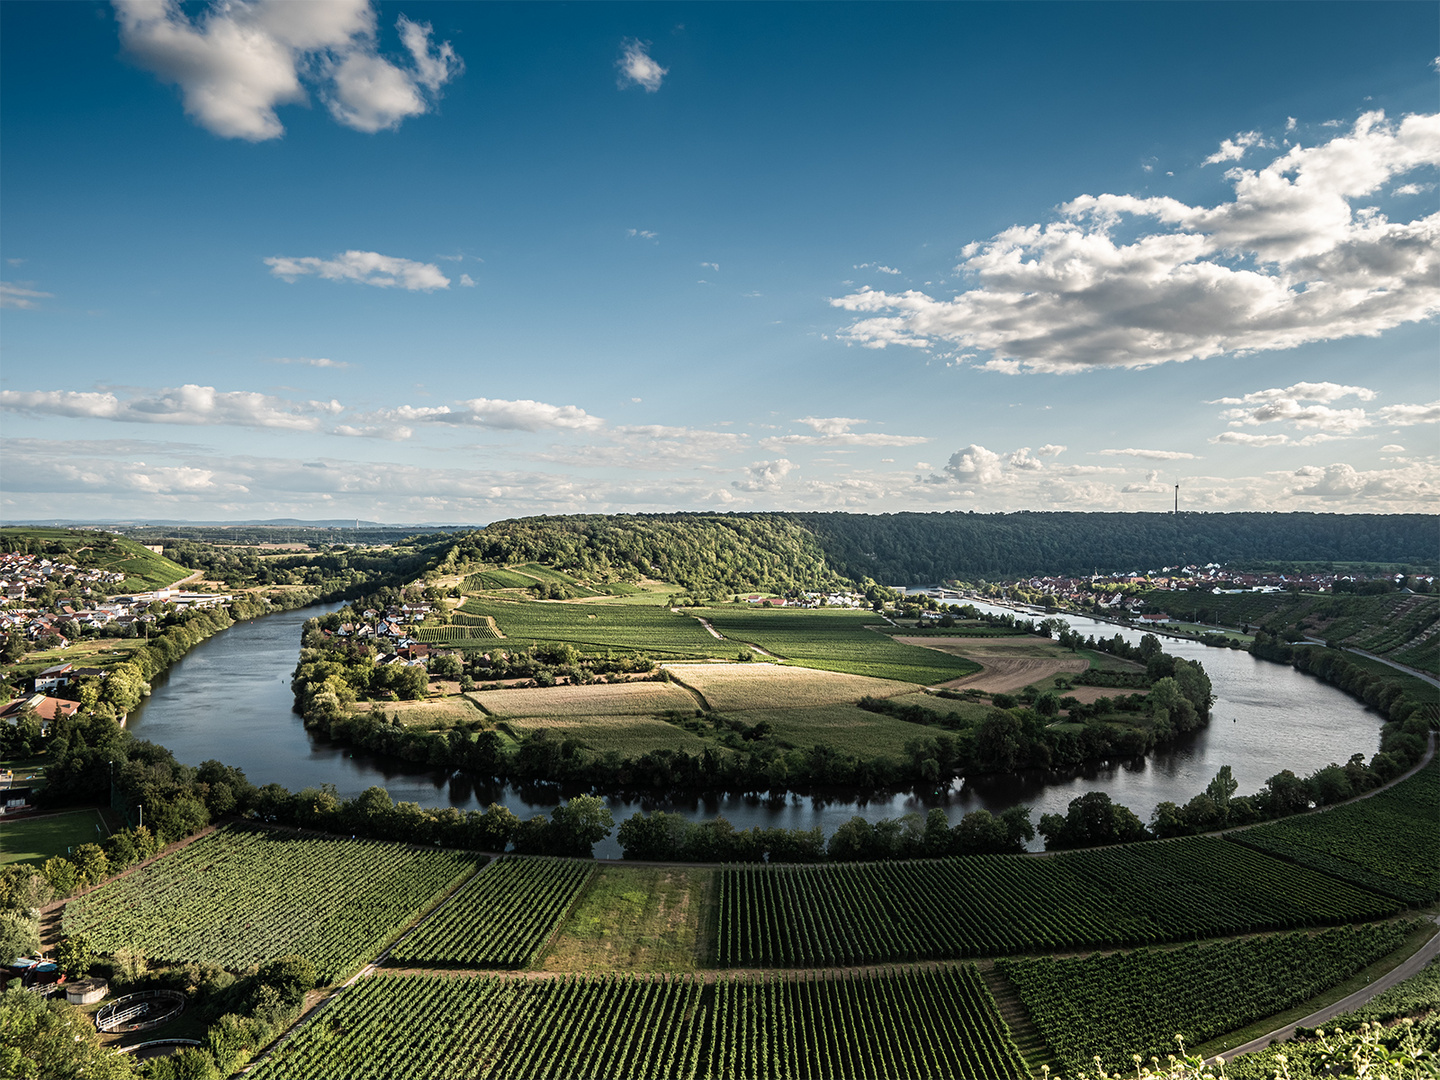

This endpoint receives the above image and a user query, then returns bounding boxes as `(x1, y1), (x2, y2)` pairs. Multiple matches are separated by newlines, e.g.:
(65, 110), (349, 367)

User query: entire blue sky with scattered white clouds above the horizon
(0, 0), (1440, 523)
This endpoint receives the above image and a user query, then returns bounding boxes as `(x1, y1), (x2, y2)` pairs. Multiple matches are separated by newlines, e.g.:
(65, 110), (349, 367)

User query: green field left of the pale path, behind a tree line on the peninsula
(459, 596), (736, 658)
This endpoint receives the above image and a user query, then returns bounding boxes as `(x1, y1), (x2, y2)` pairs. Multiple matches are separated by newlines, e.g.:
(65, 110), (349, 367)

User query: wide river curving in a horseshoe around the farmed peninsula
(130, 605), (1381, 857)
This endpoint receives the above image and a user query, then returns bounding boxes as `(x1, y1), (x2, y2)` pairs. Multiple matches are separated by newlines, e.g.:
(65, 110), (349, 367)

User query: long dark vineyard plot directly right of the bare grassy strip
(716, 837), (1403, 968)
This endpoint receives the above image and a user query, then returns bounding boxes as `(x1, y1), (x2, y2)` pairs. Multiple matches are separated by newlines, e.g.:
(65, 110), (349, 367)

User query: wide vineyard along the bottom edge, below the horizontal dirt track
(249, 966), (1027, 1080)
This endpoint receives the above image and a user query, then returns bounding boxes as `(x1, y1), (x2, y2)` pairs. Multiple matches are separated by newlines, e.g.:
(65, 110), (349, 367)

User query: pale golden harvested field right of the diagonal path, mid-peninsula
(665, 664), (914, 711)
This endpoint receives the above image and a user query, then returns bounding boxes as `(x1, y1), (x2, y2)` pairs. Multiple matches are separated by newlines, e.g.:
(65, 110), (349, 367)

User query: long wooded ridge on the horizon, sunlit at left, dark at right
(440, 511), (1440, 592)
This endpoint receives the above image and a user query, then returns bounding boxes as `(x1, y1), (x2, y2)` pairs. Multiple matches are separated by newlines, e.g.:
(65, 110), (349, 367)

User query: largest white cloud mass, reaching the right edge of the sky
(831, 111), (1440, 372)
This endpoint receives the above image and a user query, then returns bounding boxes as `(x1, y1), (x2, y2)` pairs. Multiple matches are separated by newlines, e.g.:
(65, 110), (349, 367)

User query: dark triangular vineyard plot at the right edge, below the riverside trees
(1231, 762), (1440, 904)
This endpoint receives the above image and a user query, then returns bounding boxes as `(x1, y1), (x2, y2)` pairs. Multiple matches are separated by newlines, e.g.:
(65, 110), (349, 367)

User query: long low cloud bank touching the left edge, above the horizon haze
(0, 383), (344, 431)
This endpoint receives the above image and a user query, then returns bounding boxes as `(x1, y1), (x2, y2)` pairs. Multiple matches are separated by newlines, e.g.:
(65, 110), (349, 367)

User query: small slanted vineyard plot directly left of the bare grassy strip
(390, 857), (595, 968)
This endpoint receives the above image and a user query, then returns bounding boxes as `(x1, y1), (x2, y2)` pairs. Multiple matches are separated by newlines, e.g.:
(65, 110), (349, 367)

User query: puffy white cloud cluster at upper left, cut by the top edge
(114, 0), (462, 141)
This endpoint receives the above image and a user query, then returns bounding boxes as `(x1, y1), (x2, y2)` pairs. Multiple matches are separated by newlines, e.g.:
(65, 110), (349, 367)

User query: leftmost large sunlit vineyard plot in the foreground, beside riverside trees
(63, 825), (475, 981)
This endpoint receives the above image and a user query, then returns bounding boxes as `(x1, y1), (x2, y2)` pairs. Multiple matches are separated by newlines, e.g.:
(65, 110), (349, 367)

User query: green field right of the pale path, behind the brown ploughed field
(701, 605), (976, 685)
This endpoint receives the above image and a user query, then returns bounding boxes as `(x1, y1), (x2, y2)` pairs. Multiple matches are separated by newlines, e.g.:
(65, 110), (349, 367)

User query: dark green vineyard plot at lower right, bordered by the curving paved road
(995, 923), (1411, 1074)
